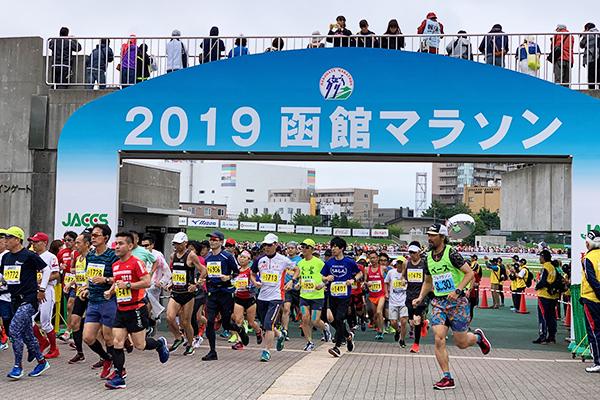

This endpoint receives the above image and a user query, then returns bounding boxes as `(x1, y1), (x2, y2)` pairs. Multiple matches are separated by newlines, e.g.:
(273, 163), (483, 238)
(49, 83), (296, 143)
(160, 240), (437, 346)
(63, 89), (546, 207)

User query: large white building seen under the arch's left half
(139, 160), (315, 219)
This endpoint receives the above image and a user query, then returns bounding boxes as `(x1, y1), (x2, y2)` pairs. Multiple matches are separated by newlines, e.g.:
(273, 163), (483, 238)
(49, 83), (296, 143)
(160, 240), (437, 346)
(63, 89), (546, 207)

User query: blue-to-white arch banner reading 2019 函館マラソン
(55, 48), (600, 282)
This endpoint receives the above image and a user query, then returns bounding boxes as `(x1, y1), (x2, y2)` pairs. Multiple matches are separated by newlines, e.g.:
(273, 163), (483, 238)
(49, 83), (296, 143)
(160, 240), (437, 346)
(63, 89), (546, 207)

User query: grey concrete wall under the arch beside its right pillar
(500, 164), (572, 232)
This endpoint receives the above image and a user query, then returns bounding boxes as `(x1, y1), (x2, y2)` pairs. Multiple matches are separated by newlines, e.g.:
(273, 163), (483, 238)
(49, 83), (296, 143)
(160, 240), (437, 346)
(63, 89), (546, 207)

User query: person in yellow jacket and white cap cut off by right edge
(580, 229), (600, 372)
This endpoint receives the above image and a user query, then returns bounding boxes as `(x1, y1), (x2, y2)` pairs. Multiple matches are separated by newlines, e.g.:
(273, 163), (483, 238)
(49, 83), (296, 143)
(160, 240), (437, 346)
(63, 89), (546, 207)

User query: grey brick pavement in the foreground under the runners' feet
(0, 338), (600, 400)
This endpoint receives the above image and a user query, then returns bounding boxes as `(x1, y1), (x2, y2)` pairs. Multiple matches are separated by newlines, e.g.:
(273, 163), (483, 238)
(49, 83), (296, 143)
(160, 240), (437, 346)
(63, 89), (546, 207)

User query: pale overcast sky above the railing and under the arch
(0, 0), (600, 208)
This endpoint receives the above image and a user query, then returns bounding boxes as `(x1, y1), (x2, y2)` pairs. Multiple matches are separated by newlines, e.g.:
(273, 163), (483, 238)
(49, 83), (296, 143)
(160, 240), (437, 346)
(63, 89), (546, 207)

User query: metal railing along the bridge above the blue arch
(45, 32), (600, 90)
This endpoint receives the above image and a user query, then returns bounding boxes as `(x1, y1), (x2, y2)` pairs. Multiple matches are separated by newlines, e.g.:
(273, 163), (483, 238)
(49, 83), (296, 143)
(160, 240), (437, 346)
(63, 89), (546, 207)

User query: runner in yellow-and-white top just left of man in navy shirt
(65, 233), (92, 364)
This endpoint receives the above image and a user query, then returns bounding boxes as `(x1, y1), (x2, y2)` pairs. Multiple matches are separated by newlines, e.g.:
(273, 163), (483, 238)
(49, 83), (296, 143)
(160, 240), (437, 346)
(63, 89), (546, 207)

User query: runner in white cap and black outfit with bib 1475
(403, 241), (429, 353)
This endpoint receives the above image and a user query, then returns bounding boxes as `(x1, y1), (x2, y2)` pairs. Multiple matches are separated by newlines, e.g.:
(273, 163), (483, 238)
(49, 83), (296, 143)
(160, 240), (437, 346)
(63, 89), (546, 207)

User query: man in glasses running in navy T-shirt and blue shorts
(79, 224), (118, 379)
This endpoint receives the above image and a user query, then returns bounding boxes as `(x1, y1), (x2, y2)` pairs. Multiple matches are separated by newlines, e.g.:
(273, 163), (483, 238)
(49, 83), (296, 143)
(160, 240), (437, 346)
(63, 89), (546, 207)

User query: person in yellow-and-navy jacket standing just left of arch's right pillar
(532, 250), (562, 344)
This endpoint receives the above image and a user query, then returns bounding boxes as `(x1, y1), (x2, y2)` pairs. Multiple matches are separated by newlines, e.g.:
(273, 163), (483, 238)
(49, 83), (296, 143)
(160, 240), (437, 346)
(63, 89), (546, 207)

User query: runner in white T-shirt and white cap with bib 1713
(250, 233), (300, 362)
